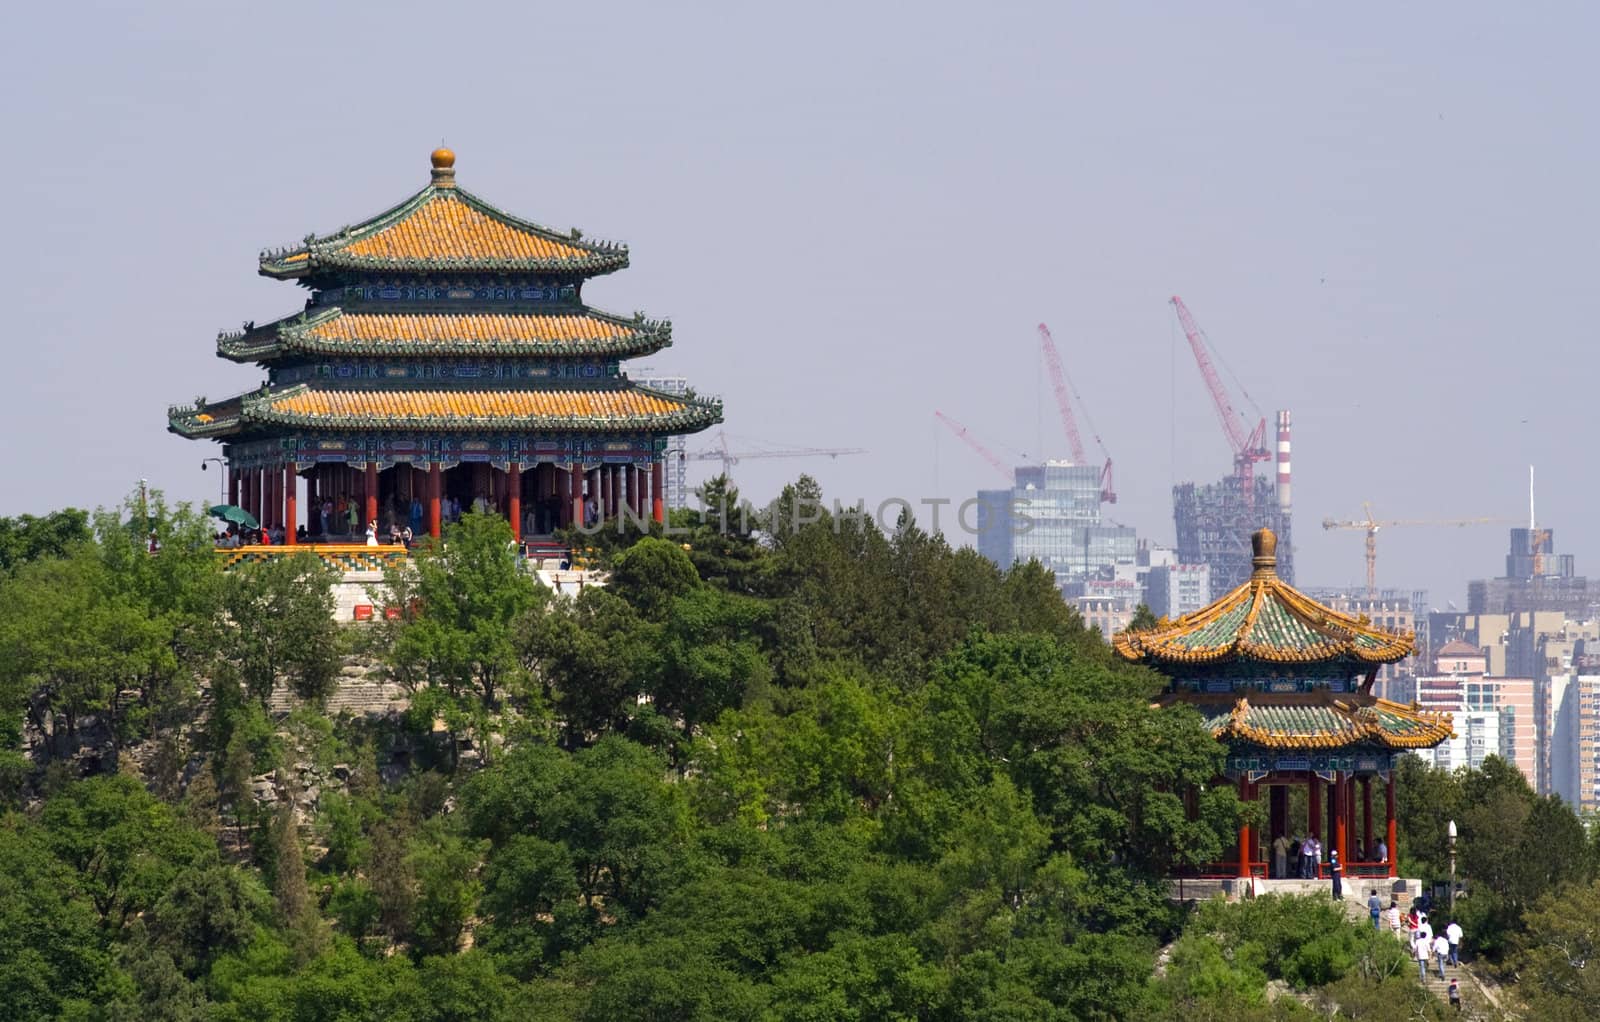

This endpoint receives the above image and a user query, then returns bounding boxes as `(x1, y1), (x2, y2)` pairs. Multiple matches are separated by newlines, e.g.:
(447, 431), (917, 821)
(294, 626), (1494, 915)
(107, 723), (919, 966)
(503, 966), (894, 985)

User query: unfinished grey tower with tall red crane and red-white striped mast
(1171, 297), (1294, 593)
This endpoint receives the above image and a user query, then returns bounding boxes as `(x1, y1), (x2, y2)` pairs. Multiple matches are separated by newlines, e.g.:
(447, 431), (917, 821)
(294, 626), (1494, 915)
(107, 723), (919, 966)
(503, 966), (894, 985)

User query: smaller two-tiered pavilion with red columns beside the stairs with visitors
(1112, 529), (1451, 876)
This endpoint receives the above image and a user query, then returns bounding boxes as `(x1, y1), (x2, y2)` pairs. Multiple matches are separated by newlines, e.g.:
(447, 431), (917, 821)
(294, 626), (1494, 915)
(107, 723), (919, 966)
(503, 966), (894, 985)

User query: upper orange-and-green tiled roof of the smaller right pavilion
(1112, 529), (1416, 664)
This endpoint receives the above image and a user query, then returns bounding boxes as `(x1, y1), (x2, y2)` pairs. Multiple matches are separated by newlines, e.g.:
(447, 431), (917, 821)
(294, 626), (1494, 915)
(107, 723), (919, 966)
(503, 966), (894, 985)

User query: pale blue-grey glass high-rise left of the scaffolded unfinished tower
(978, 461), (1139, 585)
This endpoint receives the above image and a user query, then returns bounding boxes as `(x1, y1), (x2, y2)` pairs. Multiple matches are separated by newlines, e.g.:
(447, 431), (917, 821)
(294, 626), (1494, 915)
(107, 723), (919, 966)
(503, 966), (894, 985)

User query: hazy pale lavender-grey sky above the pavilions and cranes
(0, 2), (1600, 606)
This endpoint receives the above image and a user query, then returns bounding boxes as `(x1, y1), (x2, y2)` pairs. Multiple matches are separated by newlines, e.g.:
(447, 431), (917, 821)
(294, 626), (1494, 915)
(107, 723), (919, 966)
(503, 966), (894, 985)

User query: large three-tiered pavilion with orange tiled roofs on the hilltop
(168, 149), (722, 542)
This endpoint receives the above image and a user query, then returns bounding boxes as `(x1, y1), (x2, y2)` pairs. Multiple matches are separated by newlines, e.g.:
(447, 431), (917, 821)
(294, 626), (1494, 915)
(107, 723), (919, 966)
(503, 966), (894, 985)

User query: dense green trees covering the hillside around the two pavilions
(0, 480), (1600, 1022)
